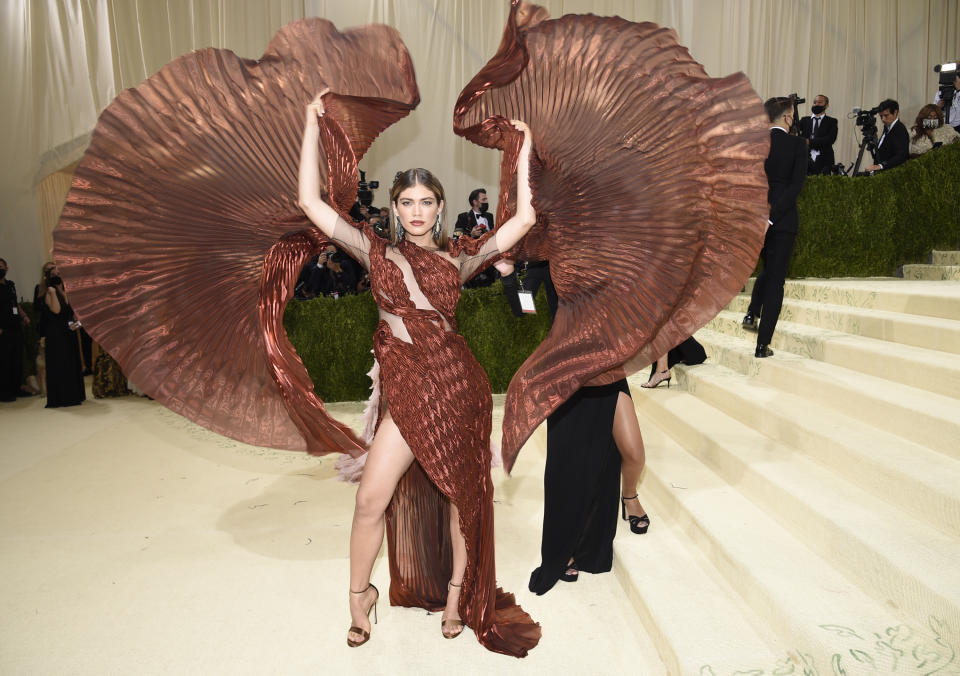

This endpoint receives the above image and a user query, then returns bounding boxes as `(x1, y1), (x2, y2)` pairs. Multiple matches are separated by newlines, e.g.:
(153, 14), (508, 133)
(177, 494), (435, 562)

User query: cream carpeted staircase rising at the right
(616, 272), (960, 676)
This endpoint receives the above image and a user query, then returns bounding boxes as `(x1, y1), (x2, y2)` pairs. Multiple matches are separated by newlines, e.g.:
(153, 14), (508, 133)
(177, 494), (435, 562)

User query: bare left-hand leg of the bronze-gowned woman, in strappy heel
(348, 413), (413, 641)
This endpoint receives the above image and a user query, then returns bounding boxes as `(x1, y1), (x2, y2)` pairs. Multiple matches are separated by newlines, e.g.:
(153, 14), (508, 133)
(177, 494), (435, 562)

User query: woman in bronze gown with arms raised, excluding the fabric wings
(300, 92), (539, 655)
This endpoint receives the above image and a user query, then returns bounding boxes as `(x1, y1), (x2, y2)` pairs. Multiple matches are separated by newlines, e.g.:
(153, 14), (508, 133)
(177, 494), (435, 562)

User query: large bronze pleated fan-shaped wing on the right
(454, 0), (769, 470)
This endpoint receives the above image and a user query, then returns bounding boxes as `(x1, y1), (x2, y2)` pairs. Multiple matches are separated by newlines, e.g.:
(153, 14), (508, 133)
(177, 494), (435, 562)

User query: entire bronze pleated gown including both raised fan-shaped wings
(54, 2), (769, 655)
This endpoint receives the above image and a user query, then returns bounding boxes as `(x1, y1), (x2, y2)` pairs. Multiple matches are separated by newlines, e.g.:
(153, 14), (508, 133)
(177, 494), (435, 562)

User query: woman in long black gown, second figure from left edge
(43, 267), (87, 408)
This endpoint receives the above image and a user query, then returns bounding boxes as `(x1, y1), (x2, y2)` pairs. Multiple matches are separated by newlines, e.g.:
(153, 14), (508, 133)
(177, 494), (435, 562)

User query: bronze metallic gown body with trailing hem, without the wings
(366, 228), (540, 657)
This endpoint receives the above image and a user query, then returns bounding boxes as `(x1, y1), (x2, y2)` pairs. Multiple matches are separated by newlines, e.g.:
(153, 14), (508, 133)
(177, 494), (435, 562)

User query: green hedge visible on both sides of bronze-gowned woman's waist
(283, 282), (550, 401)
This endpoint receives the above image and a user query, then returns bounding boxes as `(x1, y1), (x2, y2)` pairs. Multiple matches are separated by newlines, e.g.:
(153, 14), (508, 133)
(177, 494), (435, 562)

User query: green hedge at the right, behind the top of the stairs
(790, 143), (960, 277)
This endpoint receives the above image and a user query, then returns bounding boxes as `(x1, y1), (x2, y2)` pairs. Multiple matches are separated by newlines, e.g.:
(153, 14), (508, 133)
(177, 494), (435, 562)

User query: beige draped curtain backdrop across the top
(0, 0), (960, 288)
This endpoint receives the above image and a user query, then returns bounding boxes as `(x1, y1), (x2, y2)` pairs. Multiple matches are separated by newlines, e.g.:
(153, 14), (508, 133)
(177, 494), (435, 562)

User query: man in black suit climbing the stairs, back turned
(743, 96), (807, 358)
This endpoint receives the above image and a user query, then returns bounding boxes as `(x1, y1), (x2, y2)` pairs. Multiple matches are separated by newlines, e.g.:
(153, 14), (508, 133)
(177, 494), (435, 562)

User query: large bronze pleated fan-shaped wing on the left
(54, 19), (419, 453)
